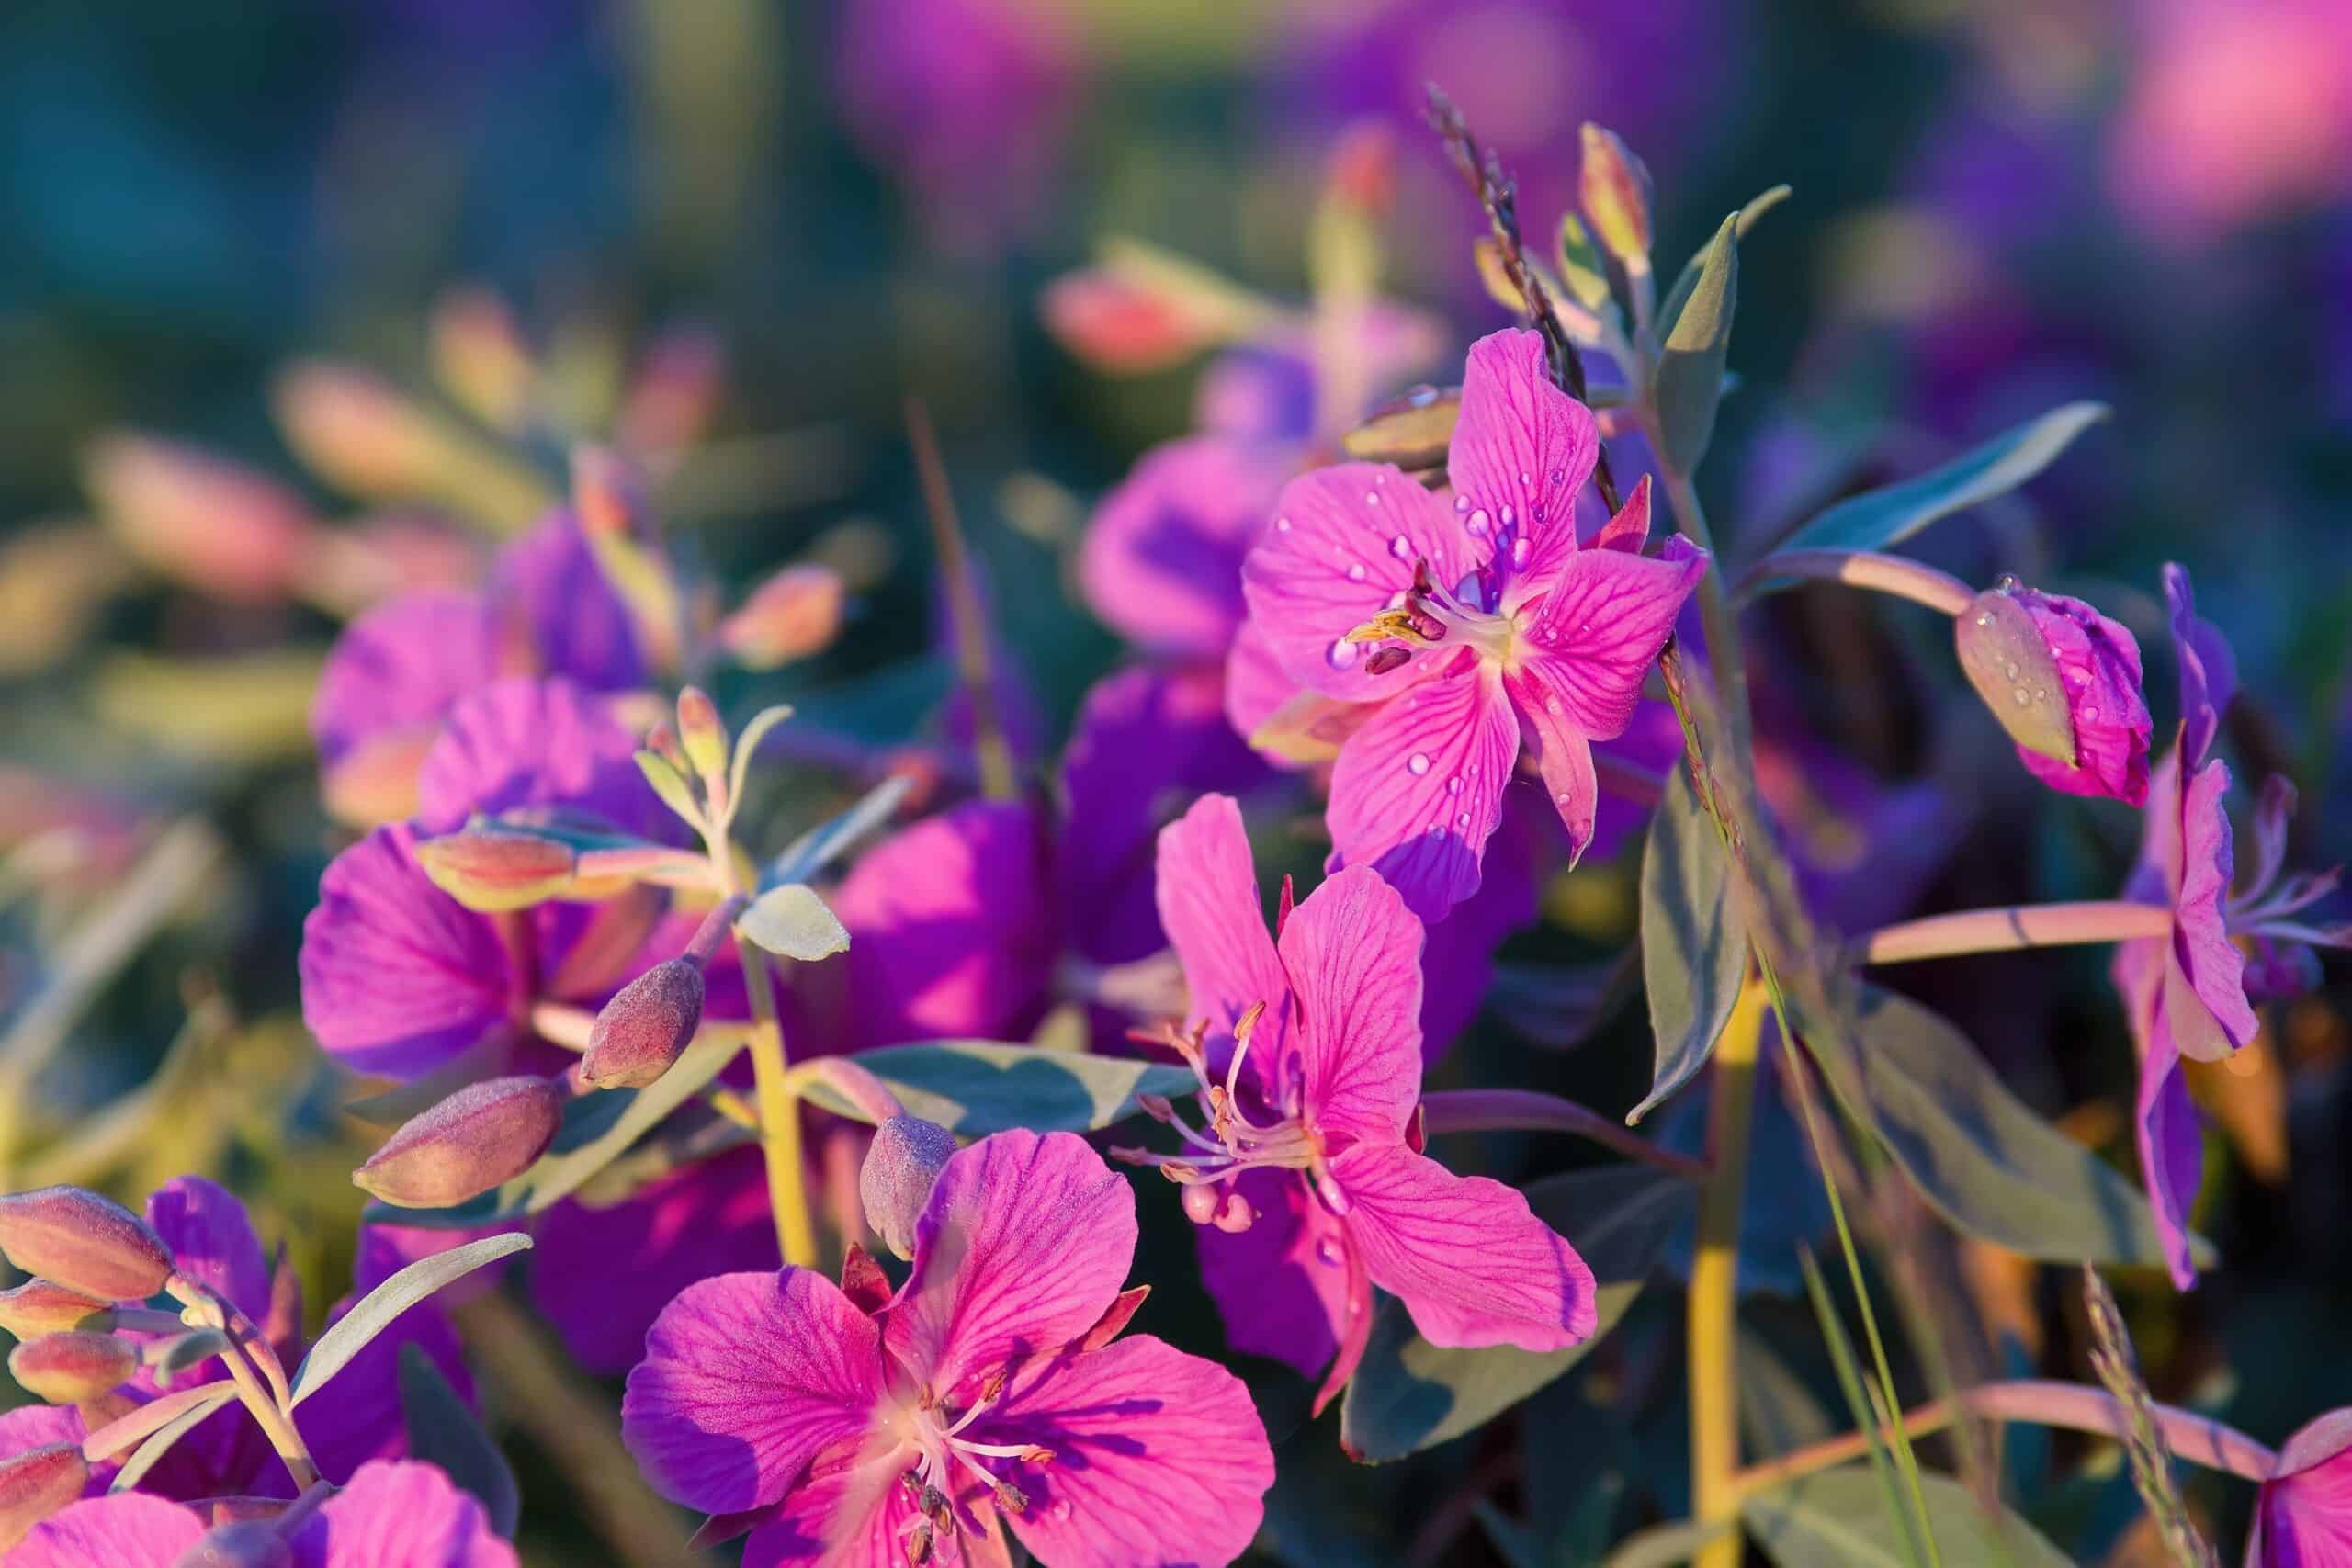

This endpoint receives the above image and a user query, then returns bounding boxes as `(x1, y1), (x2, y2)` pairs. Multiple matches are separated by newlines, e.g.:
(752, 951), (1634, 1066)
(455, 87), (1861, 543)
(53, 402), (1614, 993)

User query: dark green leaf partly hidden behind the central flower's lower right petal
(1340, 1166), (1698, 1464)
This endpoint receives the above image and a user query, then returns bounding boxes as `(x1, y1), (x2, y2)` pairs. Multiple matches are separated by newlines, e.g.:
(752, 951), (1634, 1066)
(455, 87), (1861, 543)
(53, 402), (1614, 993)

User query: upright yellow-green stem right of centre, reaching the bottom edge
(1689, 978), (1764, 1568)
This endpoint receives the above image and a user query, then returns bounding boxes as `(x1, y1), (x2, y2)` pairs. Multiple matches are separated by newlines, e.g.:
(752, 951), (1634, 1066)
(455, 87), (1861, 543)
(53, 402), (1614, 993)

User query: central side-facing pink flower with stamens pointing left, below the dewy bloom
(1122, 795), (1595, 1408)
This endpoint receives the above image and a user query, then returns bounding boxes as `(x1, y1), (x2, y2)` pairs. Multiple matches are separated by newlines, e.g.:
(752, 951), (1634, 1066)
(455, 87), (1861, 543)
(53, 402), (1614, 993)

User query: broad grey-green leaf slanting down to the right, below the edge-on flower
(1802, 985), (2211, 1267)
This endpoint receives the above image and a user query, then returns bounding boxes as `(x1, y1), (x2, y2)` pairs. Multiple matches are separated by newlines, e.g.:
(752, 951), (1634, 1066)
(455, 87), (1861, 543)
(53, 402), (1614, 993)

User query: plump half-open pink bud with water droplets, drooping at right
(1952, 579), (2154, 807)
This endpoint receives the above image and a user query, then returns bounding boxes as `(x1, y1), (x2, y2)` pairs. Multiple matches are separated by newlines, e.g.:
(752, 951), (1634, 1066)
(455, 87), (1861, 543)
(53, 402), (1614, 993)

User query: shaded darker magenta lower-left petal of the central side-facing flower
(1200, 1170), (1348, 1378)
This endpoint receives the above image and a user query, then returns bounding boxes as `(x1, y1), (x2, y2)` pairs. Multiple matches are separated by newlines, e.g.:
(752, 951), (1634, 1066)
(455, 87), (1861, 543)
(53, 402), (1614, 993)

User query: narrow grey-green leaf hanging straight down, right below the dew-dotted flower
(1625, 766), (1747, 1126)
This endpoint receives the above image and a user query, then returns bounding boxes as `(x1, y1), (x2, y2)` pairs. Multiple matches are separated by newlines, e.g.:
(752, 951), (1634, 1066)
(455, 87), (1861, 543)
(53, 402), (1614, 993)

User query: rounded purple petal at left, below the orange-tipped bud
(299, 825), (508, 1079)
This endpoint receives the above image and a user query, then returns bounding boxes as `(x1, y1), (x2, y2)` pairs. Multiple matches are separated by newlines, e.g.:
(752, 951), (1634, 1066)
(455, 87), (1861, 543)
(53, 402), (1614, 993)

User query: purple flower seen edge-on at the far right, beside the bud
(2112, 564), (2352, 1291)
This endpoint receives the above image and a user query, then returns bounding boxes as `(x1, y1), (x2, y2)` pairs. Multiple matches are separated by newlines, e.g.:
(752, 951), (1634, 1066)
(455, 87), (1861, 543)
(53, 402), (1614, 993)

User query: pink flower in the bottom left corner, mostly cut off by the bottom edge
(7, 1460), (517, 1568)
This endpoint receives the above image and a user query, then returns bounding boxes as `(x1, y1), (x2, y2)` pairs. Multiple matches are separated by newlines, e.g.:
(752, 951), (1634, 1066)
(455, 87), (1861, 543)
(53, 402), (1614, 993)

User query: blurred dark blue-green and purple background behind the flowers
(0, 0), (2352, 1561)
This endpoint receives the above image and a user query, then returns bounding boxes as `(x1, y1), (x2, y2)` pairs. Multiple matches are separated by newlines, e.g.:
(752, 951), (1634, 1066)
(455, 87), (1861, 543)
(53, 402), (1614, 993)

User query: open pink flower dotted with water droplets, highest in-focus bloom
(1242, 332), (1705, 919)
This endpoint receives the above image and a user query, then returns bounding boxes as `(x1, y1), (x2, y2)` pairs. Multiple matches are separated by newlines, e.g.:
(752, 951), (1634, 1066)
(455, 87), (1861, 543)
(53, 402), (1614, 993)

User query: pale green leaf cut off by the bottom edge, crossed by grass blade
(1740, 1464), (2067, 1568)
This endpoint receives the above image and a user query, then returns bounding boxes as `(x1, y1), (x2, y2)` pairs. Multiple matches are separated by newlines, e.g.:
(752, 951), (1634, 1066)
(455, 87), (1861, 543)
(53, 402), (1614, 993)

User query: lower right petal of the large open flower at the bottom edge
(978, 1336), (1275, 1568)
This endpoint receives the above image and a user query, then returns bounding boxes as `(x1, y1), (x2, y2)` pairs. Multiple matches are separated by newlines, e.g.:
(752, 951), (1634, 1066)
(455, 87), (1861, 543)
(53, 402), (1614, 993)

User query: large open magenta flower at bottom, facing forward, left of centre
(621, 1131), (1275, 1568)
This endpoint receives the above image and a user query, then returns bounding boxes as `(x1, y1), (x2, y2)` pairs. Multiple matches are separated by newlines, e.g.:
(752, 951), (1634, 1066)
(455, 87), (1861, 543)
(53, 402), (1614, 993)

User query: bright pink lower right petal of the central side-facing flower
(1331, 1143), (1595, 1349)
